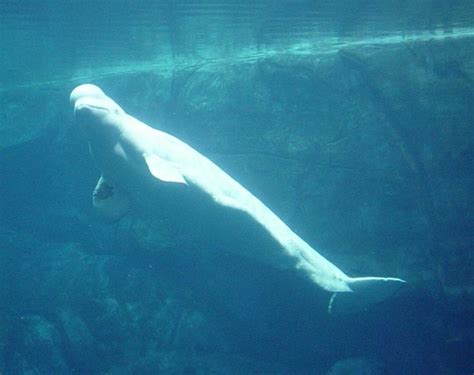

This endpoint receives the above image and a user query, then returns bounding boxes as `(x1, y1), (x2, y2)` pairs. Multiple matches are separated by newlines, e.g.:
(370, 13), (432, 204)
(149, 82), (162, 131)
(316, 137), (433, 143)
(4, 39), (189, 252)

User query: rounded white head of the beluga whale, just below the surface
(69, 84), (125, 141)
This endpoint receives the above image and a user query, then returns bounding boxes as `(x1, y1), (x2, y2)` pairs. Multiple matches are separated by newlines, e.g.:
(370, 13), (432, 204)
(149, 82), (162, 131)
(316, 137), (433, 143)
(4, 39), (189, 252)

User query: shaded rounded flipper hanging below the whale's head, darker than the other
(92, 176), (130, 222)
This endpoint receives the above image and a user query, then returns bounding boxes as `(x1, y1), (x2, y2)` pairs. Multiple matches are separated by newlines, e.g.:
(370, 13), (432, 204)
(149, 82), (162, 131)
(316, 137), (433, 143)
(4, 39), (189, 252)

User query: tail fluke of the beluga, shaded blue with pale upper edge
(328, 277), (405, 314)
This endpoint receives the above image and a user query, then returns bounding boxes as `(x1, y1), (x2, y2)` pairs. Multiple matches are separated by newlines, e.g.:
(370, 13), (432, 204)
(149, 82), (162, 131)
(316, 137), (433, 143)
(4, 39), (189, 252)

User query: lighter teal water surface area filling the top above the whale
(0, 0), (474, 90)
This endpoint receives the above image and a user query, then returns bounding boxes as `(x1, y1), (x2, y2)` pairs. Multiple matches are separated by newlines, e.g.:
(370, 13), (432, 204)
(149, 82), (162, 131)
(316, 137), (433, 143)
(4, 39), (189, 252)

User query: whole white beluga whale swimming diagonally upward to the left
(70, 84), (405, 312)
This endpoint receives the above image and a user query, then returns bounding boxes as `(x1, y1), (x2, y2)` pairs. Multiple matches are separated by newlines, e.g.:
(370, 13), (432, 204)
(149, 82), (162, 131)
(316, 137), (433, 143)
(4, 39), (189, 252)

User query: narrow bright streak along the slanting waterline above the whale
(0, 28), (474, 93)
